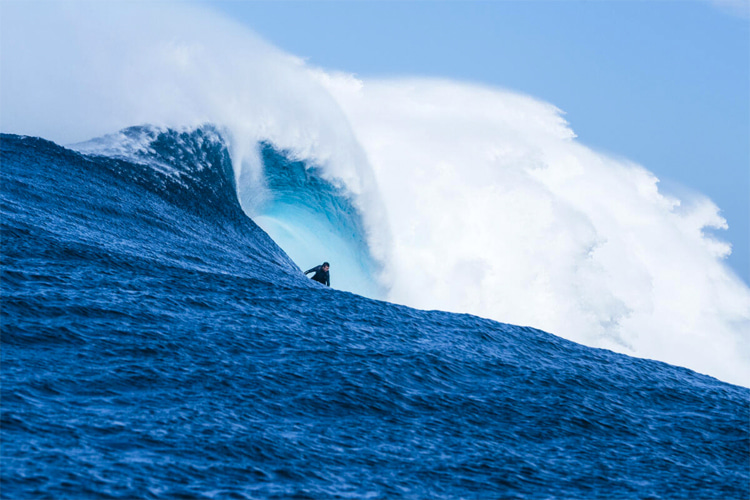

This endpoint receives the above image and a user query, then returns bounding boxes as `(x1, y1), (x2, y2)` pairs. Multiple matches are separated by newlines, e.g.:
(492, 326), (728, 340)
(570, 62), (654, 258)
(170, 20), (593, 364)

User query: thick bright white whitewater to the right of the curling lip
(322, 75), (750, 384)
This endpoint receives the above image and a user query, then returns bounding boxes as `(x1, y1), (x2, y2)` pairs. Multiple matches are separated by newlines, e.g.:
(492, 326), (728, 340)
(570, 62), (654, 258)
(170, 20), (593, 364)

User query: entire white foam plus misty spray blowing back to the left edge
(0, 3), (750, 386)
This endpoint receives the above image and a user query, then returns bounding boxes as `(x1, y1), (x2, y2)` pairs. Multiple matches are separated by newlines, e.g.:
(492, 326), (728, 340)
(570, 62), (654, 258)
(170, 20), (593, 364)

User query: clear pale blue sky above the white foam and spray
(209, 0), (750, 282)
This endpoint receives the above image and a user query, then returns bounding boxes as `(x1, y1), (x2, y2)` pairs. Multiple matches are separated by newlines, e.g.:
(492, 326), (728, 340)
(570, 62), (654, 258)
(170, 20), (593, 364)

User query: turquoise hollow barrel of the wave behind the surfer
(253, 142), (385, 298)
